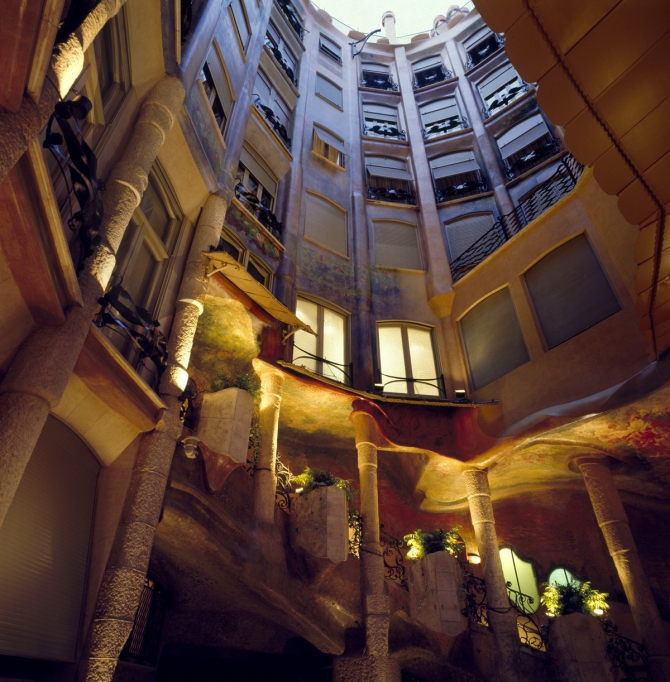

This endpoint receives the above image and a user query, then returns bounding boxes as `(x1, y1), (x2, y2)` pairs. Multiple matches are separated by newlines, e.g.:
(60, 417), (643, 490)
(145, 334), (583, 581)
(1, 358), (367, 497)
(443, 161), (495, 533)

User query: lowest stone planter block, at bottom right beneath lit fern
(550, 613), (615, 682)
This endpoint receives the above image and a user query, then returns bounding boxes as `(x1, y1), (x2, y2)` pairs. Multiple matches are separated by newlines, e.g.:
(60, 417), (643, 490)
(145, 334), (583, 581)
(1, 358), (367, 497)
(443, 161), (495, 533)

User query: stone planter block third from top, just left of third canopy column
(408, 552), (467, 636)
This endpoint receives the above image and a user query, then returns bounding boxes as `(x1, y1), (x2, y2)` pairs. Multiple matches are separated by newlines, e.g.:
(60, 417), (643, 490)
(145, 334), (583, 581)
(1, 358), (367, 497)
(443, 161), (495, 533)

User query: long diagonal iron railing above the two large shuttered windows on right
(451, 154), (584, 282)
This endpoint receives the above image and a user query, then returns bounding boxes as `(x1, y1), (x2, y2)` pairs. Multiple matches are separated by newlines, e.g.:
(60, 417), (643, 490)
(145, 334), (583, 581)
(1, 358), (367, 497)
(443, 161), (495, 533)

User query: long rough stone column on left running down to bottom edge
(77, 195), (226, 682)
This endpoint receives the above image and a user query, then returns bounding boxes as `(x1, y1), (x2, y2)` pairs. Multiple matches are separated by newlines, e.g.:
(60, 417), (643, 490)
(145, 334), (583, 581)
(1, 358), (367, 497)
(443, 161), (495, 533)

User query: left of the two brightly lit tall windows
(293, 296), (351, 384)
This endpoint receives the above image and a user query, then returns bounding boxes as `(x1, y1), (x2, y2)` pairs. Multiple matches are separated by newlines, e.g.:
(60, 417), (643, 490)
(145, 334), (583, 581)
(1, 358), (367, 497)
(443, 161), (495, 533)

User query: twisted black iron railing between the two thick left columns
(94, 283), (168, 384)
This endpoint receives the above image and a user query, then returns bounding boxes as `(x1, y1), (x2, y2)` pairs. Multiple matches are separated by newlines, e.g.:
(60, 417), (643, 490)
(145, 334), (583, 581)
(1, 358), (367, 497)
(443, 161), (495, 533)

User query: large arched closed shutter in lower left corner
(0, 417), (100, 661)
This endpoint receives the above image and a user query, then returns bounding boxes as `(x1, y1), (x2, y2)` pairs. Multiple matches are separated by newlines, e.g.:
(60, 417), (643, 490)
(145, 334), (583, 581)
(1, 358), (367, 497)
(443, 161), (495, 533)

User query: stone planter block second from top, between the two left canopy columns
(291, 486), (350, 560)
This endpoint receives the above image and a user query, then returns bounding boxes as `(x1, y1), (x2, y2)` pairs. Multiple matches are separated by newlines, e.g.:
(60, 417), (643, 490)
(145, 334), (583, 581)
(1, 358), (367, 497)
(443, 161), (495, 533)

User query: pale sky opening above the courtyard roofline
(315, 0), (465, 37)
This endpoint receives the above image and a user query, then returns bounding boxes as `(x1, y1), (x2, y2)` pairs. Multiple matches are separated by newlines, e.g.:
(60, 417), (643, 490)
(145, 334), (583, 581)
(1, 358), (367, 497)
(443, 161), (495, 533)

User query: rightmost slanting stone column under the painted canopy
(578, 461), (670, 682)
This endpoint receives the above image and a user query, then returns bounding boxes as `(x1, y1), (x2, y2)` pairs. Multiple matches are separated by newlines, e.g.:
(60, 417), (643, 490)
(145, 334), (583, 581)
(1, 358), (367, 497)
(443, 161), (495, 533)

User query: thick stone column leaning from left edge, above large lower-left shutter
(0, 76), (184, 524)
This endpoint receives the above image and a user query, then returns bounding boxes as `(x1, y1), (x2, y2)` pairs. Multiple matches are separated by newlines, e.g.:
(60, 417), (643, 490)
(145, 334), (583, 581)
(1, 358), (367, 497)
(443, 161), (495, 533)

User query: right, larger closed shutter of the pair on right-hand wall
(525, 234), (621, 348)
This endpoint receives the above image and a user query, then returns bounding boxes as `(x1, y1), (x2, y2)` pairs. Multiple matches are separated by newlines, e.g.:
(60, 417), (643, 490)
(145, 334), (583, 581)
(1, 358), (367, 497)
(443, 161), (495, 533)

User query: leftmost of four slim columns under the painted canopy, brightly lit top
(254, 362), (284, 524)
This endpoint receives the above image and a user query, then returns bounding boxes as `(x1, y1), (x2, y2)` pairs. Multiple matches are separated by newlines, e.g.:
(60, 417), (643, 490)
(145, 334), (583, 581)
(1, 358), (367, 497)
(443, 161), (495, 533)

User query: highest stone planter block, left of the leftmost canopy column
(198, 388), (254, 462)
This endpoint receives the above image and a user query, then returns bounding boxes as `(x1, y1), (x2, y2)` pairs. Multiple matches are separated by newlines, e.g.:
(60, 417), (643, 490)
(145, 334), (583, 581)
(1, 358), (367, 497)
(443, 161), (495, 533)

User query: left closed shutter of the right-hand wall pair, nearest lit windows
(461, 287), (530, 390)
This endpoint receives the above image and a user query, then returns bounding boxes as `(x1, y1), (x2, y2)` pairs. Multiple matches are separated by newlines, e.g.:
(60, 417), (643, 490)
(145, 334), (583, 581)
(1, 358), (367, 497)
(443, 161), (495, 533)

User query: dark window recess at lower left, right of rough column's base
(119, 577), (167, 667)
